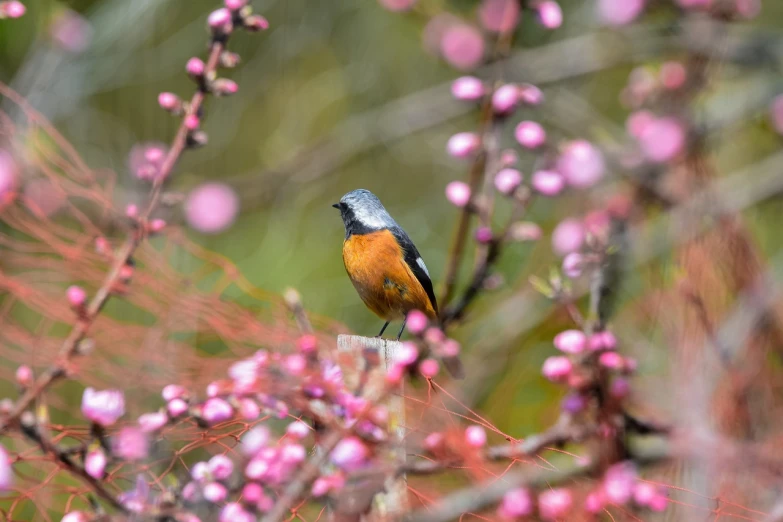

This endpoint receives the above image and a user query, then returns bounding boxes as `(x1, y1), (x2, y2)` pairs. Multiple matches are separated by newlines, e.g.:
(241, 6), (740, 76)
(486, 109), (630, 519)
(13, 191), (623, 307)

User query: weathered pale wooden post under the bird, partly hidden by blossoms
(337, 335), (408, 520)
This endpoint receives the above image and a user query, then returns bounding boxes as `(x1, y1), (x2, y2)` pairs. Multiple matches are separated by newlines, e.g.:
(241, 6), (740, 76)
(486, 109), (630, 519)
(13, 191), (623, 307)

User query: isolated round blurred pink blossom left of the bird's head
(184, 183), (239, 234)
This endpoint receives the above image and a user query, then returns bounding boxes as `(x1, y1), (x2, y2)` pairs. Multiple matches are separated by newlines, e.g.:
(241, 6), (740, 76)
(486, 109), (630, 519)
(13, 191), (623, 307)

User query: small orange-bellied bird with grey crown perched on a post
(332, 189), (463, 377)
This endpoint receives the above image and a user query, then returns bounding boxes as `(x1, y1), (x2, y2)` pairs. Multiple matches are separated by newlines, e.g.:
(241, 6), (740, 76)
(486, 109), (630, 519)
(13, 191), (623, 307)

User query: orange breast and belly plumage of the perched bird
(343, 230), (437, 321)
